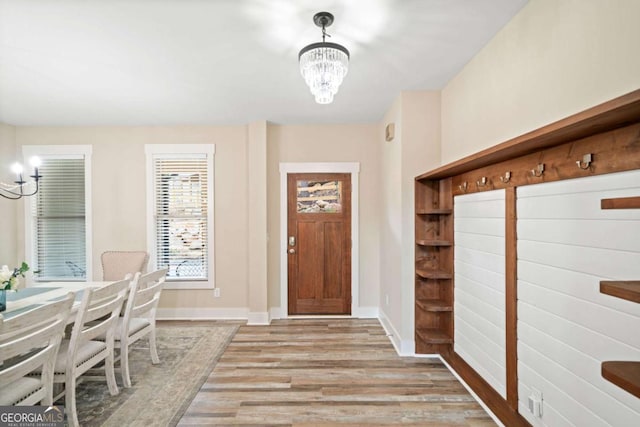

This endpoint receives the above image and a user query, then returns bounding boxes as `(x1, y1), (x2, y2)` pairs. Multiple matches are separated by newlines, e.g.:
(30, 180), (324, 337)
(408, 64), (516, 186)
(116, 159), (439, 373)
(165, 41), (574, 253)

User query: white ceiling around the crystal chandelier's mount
(0, 0), (527, 126)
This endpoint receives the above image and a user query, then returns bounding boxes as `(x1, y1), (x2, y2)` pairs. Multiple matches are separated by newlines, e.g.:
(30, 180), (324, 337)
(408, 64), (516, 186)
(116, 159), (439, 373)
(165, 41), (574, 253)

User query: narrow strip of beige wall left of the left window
(0, 123), (18, 268)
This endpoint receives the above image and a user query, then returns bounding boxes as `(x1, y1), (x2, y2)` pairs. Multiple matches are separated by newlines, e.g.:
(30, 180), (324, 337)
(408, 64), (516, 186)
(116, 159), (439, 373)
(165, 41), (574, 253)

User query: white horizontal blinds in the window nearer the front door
(153, 154), (210, 280)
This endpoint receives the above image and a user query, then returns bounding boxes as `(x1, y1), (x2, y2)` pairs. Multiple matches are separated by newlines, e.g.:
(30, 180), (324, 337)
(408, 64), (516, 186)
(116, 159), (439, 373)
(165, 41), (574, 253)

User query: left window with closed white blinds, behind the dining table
(23, 146), (91, 281)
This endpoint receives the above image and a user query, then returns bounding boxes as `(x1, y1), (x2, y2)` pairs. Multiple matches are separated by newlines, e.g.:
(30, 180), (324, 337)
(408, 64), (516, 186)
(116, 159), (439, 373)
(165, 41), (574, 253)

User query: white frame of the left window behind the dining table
(22, 145), (93, 286)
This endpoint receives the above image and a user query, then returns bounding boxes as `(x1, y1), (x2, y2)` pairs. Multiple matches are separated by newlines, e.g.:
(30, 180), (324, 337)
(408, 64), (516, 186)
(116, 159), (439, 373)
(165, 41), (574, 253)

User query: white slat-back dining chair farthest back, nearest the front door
(114, 268), (168, 388)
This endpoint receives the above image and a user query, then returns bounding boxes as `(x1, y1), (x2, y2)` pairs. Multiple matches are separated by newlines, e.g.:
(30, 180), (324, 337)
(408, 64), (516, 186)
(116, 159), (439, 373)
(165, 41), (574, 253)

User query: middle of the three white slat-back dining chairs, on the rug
(53, 280), (129, 426)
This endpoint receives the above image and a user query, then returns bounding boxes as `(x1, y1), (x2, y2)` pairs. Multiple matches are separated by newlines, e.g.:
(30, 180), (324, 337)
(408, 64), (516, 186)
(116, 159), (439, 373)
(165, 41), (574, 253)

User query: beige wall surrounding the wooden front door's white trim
(267, 124), (381, 310)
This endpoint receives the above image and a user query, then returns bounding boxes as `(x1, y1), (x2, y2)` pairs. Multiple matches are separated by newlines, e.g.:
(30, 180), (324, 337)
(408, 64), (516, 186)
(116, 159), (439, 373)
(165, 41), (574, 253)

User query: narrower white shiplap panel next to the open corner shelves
(454, 190), (506, 397)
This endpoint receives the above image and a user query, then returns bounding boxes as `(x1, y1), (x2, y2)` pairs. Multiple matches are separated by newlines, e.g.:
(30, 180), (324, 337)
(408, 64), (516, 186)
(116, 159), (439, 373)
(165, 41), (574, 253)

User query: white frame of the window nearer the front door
(144, 144), (215, 289)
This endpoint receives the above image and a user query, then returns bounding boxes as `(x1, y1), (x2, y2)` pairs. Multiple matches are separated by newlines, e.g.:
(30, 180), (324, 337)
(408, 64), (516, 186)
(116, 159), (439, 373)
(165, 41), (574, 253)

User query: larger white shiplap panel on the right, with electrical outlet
(517, 171), (640, 427)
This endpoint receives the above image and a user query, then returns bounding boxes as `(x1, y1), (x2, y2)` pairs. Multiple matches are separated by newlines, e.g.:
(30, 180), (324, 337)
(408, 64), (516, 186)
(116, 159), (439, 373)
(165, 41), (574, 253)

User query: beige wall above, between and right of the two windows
(16, 126), (248, 308)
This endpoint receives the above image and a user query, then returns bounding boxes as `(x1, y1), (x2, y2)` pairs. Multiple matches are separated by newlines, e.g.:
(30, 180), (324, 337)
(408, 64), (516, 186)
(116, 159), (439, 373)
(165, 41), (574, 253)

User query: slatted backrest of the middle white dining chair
(68, 279), (129, 364)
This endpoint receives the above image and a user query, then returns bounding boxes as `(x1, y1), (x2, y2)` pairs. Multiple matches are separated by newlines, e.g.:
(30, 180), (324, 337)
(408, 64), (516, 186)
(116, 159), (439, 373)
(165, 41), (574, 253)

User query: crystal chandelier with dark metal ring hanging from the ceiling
(298, 12), (349, 104)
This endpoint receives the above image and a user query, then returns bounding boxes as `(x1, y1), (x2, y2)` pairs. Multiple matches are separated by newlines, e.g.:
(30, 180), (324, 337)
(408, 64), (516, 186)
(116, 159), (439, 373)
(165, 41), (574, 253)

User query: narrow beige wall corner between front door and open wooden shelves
(379, 91), (440, 354)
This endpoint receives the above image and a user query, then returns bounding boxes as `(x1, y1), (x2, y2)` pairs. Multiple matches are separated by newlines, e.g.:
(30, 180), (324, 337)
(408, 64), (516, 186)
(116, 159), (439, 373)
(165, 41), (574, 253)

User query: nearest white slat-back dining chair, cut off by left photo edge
(0, 293), (74, 406)
